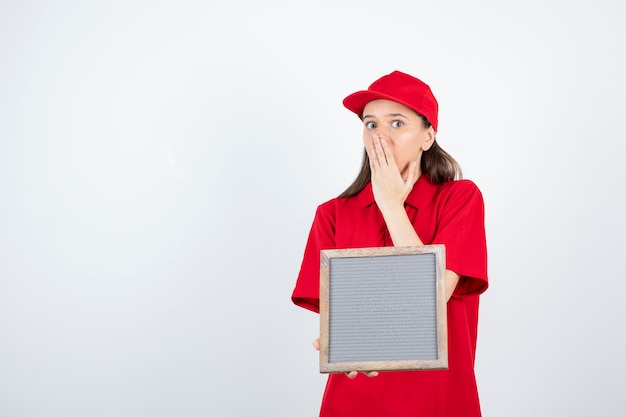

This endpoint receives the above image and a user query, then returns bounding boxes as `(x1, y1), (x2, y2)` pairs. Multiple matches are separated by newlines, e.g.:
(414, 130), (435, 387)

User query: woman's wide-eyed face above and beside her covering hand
(363, 100), (435, 178)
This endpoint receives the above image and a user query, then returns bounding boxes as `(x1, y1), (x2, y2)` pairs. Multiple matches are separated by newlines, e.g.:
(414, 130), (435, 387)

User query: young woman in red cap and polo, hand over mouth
(292, 71), (488, 417)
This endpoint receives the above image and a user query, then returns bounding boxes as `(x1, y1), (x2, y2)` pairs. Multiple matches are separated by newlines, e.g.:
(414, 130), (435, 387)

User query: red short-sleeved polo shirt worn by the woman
(292, 175), (487, 417)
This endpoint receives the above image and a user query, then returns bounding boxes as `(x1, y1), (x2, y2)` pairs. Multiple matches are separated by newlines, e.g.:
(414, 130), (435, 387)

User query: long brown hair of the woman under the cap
(339, 115), (463, 197)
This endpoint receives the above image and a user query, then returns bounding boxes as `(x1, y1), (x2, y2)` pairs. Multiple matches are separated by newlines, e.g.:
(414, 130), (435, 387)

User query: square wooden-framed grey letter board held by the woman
(320, 245), (448, 373)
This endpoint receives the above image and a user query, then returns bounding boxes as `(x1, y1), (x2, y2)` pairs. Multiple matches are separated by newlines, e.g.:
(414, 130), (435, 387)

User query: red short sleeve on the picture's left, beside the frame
(291, 200), (335, 313)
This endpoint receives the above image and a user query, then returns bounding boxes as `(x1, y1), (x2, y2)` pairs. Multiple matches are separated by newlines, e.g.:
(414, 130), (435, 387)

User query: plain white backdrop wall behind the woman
(0, 0), (626, 417)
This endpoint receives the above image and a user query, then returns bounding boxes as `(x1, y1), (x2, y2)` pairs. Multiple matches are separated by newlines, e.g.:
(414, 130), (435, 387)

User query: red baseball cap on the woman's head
(343, 71), (439, 131)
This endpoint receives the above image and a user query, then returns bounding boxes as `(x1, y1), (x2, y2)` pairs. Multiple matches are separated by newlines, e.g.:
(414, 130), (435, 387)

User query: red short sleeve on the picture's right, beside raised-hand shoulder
(433, 180), (489, 295)
